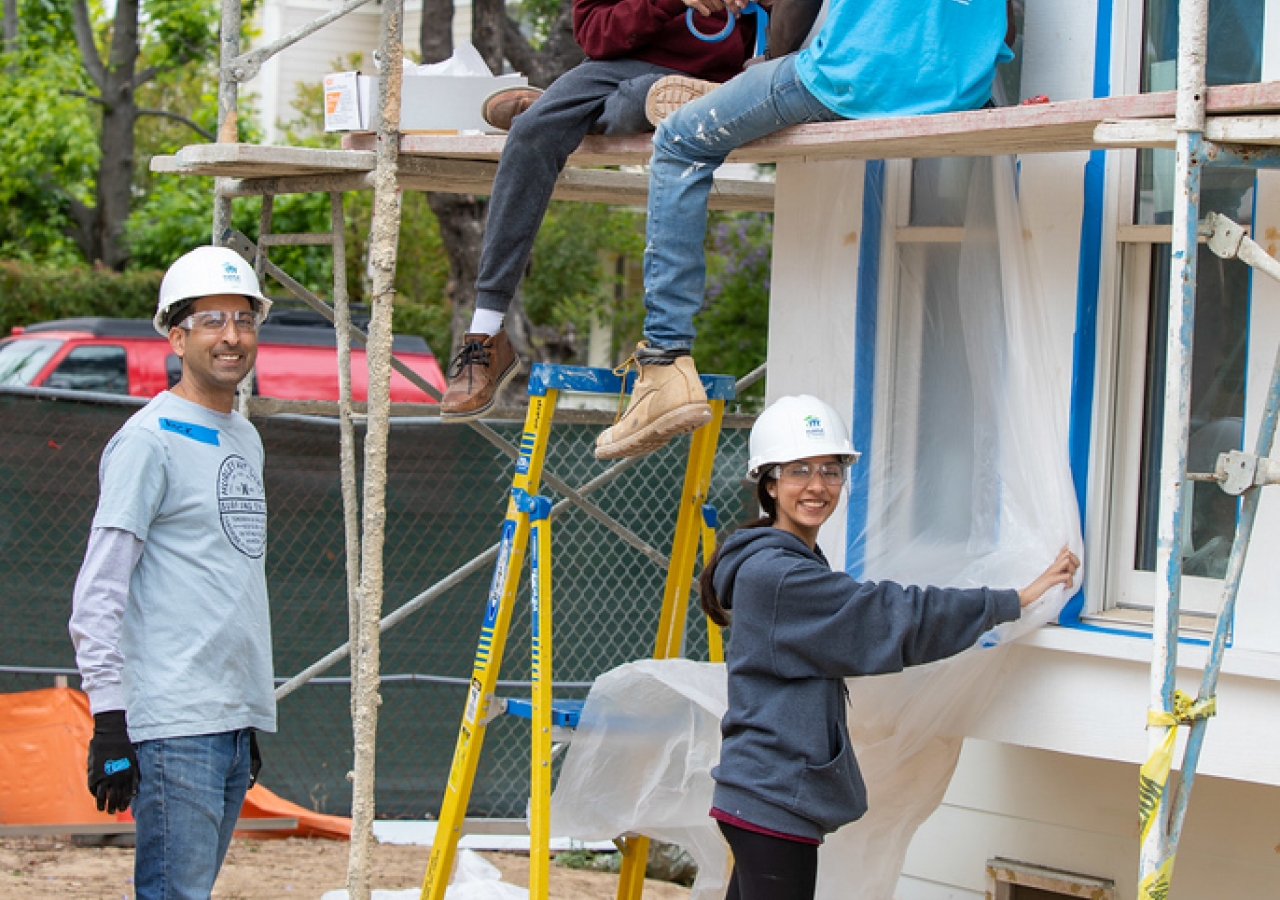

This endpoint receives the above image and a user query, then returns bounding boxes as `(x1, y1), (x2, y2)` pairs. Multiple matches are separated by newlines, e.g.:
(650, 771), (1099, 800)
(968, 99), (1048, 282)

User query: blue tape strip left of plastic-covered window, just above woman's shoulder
(845, 160), (884, 579)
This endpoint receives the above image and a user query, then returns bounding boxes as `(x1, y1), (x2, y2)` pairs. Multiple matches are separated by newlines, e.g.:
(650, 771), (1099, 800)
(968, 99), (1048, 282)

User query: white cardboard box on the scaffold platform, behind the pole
(324, 72), (529, 134)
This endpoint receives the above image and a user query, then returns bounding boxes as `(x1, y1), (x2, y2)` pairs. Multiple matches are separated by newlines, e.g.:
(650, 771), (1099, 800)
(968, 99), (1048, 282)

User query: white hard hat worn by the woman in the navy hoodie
(746, 394), (859, 481)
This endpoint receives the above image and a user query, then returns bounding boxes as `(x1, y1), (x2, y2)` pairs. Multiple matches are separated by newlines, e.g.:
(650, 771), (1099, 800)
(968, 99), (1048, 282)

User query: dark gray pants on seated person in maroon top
(476, 59), (680, 312)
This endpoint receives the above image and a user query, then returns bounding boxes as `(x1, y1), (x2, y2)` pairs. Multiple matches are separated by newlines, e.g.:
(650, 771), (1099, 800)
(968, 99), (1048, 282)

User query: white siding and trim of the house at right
(769, 0), (1280, 900)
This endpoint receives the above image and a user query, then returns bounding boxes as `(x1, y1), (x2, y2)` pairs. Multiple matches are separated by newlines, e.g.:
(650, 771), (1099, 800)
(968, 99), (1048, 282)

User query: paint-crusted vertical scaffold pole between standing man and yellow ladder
(347, 0), (404, 900)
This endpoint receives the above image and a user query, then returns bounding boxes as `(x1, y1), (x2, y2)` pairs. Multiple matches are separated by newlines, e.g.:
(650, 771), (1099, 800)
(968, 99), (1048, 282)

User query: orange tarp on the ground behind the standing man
(0, 687), (351, 840)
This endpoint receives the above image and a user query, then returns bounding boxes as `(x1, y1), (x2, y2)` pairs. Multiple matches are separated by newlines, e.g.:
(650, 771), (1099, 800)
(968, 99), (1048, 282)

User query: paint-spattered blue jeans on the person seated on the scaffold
(644, 55), (841, 350)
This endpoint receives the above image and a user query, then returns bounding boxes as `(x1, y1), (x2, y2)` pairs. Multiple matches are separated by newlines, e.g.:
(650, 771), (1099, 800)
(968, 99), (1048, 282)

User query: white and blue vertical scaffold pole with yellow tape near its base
(1138, 0), (1208, 900)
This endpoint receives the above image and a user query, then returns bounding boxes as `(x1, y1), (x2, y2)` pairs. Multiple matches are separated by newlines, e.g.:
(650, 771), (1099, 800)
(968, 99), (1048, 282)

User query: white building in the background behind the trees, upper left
(247, 0), (471, 143)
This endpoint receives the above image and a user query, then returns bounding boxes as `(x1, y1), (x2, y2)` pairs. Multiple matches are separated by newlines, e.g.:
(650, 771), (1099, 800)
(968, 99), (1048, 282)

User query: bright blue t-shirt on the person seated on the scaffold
(796, 0), (1012, 119)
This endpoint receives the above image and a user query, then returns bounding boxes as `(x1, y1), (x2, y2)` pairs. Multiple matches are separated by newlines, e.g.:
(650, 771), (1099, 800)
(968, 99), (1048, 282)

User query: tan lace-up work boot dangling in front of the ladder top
(595, 342), (712, 460)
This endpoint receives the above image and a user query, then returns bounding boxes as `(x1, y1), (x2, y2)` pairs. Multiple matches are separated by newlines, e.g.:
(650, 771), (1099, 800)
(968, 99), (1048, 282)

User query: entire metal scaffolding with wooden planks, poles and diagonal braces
(177, 0), (1280, 900)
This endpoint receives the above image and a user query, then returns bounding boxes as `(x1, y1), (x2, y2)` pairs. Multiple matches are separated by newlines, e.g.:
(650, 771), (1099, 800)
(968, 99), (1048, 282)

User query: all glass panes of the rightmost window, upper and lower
(1134, 0), (1263, 579)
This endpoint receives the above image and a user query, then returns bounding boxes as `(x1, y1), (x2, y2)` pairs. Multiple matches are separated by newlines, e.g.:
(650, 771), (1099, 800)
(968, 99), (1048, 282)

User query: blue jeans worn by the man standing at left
(133, 728), (250, 900)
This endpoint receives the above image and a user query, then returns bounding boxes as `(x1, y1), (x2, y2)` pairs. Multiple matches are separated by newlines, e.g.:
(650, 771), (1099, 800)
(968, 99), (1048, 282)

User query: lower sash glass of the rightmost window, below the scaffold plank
(1134, 245), (1249, 579)
